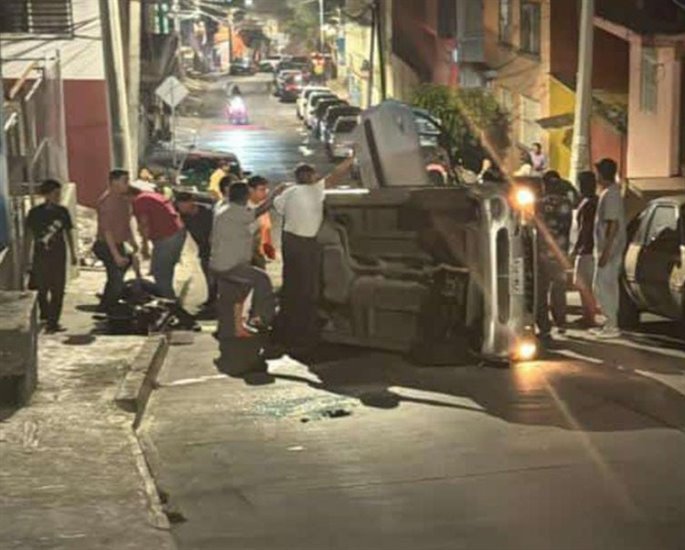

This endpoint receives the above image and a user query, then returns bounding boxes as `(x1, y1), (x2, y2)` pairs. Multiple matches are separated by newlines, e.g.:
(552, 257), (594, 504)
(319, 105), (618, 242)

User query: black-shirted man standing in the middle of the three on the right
(572, 171), (597, 328)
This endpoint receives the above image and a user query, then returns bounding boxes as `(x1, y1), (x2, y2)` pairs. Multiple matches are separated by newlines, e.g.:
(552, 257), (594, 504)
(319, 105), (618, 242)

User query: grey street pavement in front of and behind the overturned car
(141, 76), (685, 550)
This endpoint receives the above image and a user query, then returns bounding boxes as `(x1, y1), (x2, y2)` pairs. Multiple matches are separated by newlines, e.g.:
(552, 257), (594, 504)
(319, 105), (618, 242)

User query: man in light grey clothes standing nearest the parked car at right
(592, 158), (627, 339)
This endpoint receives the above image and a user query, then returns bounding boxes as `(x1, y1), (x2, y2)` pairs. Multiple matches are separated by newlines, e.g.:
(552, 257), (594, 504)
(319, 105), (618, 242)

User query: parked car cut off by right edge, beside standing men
(619, 195), (685, 328)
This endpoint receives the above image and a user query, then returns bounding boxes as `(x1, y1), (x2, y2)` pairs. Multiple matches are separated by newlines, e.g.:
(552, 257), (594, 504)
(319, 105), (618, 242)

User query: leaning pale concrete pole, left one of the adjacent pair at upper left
(100, 0), (132, 170)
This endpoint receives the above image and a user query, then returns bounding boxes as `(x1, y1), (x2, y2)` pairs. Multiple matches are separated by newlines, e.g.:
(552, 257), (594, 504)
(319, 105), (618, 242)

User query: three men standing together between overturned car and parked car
(536, 159), (626, 340)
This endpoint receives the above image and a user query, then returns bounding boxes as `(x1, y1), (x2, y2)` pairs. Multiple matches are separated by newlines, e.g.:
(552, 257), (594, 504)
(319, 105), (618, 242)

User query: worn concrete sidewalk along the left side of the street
(0, 271), (174, 550)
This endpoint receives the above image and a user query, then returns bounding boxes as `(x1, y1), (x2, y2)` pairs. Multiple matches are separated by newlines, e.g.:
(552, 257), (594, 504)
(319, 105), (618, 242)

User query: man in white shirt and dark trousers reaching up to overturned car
(274, 158), (353, 349)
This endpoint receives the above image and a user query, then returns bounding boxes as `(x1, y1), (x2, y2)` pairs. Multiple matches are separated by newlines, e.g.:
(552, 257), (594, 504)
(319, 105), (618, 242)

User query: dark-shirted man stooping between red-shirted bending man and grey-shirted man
(176, 192), (216, 306)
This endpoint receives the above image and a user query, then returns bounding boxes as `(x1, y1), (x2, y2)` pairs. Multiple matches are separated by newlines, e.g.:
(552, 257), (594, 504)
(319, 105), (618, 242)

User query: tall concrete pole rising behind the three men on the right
(570, 0), (595, 185)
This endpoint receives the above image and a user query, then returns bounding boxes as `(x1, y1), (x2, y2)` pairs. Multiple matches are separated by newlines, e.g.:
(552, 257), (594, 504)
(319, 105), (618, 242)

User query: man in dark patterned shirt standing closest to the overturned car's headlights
(536, 178), (573, 340)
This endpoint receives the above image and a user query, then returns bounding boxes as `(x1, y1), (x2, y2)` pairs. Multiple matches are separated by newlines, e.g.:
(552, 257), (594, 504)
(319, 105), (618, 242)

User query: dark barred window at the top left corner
(0, 0), (74, 36)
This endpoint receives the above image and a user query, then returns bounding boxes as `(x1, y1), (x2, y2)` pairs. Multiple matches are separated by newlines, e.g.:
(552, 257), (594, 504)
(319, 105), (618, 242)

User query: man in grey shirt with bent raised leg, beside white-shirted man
(209, 182), (282, 338)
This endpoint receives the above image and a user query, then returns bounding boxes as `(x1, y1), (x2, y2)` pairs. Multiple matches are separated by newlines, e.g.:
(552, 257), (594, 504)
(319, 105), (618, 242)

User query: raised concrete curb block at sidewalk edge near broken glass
(114, 336), (169, 429)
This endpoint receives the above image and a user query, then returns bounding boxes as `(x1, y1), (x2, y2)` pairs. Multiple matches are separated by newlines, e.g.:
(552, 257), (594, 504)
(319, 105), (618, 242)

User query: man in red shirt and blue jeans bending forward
(130, 182), (186, 299)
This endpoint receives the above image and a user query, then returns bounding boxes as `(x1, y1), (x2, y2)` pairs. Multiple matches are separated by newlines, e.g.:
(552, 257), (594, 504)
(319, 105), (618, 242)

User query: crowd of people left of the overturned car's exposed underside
(22, 153), (351, 356)
